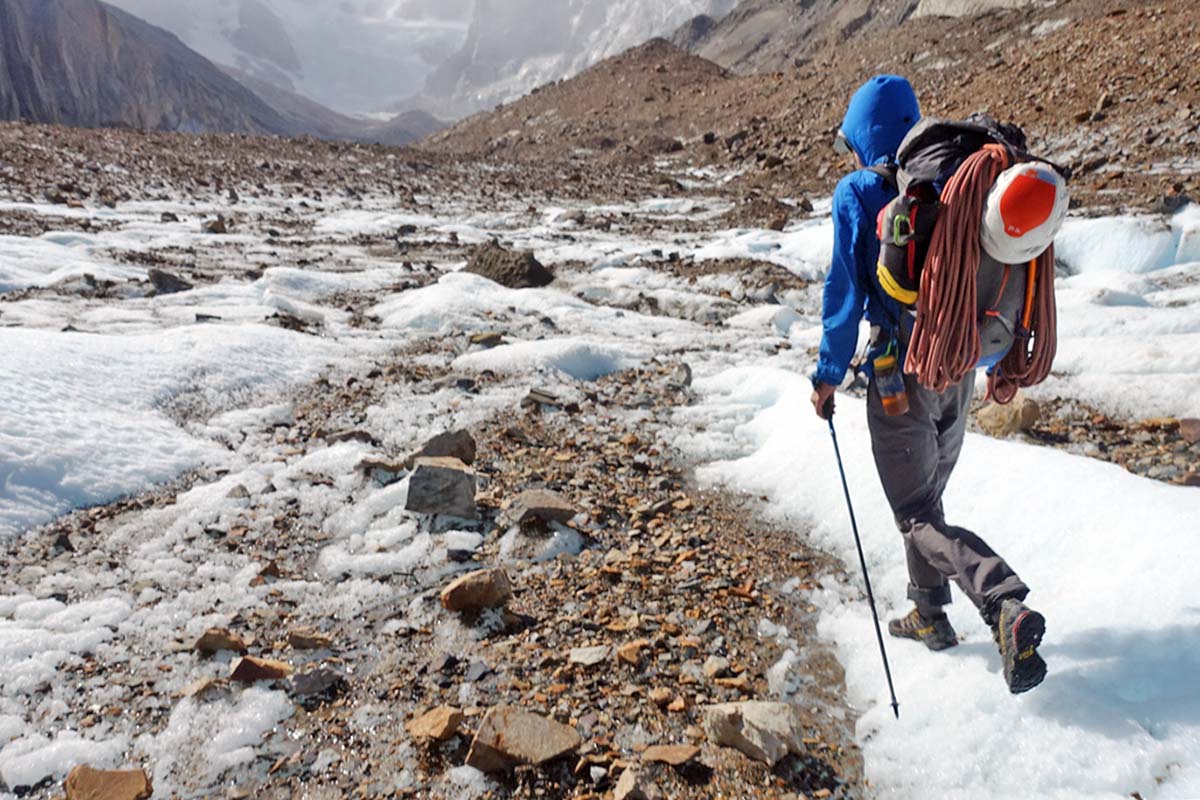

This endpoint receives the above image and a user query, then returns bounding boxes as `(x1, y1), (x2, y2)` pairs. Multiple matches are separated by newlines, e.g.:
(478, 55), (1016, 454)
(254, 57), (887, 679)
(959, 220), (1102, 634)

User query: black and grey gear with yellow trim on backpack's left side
(876, 184), (941, 307)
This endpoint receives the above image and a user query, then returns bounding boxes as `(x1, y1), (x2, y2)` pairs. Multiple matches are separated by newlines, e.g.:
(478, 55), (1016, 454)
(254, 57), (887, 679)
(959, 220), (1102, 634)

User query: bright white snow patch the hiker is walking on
(679, 367), (1200, 800)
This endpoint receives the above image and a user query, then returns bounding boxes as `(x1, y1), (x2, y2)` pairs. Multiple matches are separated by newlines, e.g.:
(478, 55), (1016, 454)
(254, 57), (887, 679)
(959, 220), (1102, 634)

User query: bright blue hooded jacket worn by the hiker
(812, 76), (920, 386)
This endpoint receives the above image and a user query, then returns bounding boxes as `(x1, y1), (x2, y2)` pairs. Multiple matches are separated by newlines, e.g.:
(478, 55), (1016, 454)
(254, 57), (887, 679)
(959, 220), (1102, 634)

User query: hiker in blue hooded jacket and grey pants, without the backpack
(812, 76), (1066, 693)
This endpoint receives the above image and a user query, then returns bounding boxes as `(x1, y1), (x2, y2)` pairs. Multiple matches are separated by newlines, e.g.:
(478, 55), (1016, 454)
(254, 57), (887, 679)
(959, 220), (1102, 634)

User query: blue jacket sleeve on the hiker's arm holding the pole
(812, 179), (875, 386)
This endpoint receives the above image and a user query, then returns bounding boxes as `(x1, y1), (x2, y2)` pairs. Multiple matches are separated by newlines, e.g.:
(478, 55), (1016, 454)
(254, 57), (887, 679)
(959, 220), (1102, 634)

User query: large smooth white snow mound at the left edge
(0, 325), (341, 537)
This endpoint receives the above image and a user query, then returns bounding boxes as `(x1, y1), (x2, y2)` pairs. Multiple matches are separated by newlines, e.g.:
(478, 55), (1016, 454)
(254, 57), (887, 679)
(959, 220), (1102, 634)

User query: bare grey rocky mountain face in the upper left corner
(0, 0), (299, 134)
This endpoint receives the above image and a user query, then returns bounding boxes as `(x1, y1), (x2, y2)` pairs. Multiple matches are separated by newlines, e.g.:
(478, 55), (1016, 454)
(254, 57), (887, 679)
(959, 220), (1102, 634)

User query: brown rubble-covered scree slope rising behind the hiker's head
(424, 0), (1200, 214)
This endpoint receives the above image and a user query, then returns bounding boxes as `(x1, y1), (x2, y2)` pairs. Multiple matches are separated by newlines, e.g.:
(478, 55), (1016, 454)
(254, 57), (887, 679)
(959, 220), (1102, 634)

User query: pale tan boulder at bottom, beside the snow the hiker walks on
(704, 700), (804, 766)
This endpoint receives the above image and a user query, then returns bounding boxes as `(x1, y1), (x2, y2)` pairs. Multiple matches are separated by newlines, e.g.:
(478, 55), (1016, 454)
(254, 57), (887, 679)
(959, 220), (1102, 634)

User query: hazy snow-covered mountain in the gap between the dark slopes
(103, 0), (734, 116)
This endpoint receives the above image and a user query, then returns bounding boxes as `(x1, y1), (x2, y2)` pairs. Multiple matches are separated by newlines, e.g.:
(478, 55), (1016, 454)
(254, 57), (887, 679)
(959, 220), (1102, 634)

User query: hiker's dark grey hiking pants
(866, 372), (1028, 624)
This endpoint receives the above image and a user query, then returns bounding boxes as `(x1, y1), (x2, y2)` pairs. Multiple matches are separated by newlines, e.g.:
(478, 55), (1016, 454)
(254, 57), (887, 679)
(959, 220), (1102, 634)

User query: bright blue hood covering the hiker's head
(841, 76), (920, 167)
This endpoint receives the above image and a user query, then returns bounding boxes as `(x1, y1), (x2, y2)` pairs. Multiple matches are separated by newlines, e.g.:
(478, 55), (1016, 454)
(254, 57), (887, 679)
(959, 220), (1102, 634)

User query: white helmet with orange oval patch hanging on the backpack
(983, 162), (1070, 264)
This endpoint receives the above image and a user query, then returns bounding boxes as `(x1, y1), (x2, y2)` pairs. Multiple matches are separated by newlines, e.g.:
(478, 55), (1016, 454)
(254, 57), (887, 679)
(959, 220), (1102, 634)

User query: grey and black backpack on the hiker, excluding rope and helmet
(870, 114), (1066, 368)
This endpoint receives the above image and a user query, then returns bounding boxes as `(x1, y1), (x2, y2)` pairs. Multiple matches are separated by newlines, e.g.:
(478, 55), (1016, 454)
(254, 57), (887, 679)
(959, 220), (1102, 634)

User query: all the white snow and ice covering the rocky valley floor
(0, 183), (1200, 800)
